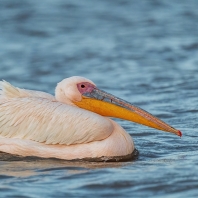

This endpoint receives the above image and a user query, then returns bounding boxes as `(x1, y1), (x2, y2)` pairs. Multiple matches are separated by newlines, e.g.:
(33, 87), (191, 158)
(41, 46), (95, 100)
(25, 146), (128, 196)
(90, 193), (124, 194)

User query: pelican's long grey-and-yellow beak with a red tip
(74, 87), (182, 137)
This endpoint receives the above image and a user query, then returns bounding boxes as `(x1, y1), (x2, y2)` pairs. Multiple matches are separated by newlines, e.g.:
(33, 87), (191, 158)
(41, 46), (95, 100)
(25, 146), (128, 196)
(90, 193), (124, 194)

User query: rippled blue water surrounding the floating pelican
(0, 0), (198, 198)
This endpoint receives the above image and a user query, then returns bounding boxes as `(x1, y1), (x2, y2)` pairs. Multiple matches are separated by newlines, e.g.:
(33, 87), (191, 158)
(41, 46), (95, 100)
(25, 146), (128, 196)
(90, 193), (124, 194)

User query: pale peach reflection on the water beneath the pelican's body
(0, 160), (129, 179)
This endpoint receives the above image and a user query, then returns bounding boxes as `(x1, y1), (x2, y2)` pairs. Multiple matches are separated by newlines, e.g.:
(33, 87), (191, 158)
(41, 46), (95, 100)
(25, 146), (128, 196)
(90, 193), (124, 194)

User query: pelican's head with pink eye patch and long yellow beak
(55, 76), (182, 137)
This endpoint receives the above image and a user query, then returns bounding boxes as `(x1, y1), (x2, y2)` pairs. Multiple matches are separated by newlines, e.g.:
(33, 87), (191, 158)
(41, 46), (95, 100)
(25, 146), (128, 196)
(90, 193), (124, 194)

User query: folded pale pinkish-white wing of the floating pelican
(0, 97), (113, 145)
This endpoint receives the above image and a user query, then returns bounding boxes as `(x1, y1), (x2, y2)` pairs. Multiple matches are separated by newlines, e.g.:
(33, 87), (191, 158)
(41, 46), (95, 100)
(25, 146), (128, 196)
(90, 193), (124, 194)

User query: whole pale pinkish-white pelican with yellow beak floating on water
(0, 76), (182, 160)
